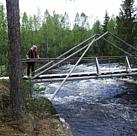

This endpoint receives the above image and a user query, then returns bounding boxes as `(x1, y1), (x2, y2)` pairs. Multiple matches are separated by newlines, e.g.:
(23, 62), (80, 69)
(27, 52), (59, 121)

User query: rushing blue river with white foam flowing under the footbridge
(35, 64), (137, 136)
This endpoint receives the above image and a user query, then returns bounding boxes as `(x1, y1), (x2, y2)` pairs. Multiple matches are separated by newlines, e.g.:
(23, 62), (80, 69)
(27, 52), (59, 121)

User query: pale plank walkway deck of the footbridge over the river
(0, 68), (137, 82)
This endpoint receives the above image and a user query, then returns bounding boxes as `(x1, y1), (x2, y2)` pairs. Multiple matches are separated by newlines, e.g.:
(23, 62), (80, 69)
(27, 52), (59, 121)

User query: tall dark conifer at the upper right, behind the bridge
(117, 0), (137, 51)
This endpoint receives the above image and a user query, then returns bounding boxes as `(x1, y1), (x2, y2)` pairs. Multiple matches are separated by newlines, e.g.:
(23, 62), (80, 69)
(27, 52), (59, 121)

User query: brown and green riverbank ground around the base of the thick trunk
(0, 82), (72, 136)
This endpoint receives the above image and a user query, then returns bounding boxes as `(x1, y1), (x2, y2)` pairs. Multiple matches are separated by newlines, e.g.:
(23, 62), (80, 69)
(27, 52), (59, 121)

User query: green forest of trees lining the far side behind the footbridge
(0, 0), (137, 65)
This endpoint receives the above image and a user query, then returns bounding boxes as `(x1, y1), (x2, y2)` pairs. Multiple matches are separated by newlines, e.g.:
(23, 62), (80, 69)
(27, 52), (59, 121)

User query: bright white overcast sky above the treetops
(0, 0), (137, 24)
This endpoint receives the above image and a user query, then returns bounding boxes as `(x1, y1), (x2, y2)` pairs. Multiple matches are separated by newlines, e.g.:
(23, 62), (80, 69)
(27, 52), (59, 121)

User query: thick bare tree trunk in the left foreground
(6, 0), (24, 117)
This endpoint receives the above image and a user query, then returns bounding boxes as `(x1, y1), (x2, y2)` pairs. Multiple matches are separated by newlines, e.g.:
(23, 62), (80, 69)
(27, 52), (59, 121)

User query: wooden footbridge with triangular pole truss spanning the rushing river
(0, 32), (137, 99)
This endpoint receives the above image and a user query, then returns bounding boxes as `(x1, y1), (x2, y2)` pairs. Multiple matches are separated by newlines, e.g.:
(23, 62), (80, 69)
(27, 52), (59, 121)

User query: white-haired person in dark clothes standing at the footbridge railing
(26, 45), (39, 77)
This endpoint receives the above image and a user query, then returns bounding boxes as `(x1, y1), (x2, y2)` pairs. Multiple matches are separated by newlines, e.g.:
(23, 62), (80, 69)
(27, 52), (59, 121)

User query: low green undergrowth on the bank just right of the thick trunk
(24, 81), (57, 114)
